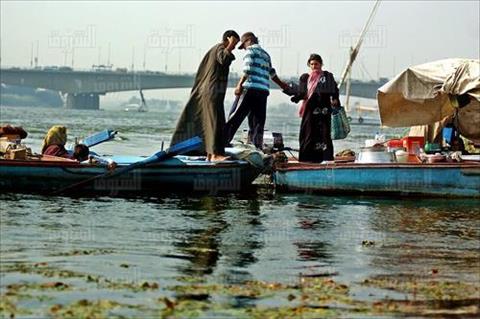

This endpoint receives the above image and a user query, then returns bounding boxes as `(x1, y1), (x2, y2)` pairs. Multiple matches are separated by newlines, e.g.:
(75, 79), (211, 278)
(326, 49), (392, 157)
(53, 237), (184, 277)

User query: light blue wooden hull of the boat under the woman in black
(273, 162), (480, 197)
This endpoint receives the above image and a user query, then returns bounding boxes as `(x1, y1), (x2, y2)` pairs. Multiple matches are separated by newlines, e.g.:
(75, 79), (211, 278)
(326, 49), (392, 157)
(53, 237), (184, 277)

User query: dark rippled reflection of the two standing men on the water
(171, 197), (262, 282)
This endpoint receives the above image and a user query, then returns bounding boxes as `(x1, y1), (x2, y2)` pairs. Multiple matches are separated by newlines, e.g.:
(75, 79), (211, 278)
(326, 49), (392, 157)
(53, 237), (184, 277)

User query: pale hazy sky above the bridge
(0, 0), (480, 79)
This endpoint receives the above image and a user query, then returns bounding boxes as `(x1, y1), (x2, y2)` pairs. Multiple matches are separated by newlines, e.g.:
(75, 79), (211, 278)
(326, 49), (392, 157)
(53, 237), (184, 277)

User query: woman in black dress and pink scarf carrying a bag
(291, 54), (340, 163)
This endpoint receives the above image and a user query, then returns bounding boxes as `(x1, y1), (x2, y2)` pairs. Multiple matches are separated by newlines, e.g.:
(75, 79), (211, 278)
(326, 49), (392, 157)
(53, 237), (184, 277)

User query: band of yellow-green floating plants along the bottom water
(0, 262), (480, 319)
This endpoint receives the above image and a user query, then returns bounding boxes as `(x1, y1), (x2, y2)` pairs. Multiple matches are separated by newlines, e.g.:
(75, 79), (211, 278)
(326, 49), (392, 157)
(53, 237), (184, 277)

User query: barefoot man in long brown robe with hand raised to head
(170, 30), (240, 161)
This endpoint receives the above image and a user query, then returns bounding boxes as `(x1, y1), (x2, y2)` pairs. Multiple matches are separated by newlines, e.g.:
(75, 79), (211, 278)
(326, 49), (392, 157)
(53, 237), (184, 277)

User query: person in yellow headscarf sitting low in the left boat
(42, 125), (89, 162)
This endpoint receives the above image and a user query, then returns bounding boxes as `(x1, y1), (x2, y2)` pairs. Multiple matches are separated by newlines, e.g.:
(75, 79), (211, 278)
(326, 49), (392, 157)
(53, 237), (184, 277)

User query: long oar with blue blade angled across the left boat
(52, 136), (202, 195)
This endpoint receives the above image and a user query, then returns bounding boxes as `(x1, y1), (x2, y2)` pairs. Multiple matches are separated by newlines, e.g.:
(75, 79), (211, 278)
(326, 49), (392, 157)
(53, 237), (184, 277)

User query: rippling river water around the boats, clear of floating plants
(0, 93), (480, 317)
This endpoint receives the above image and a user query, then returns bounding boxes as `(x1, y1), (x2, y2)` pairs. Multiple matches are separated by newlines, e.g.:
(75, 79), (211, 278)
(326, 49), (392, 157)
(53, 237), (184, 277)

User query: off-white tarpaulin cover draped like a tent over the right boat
(377, 59), (480, 140)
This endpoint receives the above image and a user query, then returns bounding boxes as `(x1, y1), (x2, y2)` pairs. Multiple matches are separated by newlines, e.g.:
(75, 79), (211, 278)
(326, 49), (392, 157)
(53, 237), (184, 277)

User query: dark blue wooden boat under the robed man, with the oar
(0, 156), (263, 195)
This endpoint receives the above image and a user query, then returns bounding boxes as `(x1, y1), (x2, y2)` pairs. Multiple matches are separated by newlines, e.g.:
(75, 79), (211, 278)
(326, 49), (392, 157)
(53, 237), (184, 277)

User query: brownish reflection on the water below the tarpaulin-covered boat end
(370, 199), (480, 282)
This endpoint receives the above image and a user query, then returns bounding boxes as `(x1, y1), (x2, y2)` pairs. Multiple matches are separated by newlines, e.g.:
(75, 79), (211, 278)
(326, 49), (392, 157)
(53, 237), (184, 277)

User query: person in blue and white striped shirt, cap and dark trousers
(225, 32), (288, 149)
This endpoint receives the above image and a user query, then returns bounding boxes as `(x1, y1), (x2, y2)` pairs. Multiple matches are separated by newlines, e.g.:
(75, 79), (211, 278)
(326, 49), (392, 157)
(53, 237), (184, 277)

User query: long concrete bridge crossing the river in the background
(0, 67), (386, 109)
